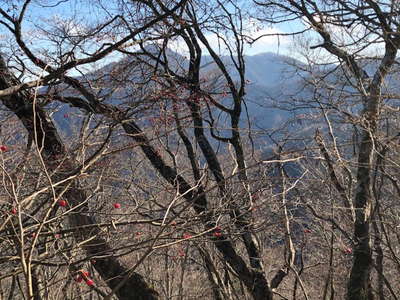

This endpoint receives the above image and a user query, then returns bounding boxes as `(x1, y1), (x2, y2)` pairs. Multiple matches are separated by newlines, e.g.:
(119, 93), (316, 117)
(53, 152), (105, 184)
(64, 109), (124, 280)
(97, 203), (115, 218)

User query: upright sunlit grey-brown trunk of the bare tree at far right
(347, 41), (397, 300)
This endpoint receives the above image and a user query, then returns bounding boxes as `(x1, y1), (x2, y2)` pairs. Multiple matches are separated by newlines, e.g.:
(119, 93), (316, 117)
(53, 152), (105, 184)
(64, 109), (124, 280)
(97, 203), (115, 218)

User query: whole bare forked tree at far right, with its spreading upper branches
(255, 1), (399, 299)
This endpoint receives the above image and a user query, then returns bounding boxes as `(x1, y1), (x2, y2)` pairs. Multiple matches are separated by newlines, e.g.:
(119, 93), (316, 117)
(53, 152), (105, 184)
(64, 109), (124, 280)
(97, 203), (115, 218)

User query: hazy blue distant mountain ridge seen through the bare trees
(41, 48), (400, 148)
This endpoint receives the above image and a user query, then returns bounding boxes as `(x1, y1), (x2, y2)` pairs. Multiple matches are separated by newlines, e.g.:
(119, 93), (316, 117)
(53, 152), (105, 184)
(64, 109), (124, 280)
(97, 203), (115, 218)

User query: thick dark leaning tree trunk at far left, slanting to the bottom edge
(0, 54), (158, 300)
